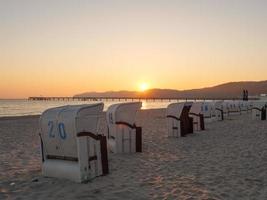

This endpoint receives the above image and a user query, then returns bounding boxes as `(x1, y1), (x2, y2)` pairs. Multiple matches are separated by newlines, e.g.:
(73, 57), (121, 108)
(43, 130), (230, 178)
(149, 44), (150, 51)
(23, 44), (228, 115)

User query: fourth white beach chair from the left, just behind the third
(189, 102), (205, 131)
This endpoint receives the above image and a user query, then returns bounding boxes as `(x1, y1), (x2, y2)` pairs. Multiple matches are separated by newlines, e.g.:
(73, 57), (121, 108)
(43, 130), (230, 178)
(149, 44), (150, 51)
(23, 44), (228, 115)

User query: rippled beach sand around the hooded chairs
(0, 109), (267, 200)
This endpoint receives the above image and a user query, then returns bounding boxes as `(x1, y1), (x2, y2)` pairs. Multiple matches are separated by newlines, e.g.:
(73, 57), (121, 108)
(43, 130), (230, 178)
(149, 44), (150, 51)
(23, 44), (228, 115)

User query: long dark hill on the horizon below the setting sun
(74, 80), (267, 98)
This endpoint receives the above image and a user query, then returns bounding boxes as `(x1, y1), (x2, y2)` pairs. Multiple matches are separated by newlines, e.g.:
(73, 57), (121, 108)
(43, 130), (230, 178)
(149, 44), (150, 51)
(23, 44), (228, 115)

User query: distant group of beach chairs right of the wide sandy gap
(166, 100), (267, 137)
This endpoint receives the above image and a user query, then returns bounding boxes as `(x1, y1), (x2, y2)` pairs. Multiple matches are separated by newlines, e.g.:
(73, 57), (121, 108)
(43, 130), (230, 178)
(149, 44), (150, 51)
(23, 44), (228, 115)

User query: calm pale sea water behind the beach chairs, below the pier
(0, 99), (188, 117)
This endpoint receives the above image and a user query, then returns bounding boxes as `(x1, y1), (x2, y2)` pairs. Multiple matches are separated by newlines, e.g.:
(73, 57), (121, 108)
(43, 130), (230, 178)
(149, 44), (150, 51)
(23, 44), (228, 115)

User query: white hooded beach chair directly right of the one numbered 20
(106, 102), (142, 153)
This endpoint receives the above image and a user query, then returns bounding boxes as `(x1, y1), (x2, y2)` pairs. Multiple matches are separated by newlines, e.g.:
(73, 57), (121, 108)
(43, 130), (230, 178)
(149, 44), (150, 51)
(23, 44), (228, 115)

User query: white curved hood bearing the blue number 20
(40, 103), (104, 157)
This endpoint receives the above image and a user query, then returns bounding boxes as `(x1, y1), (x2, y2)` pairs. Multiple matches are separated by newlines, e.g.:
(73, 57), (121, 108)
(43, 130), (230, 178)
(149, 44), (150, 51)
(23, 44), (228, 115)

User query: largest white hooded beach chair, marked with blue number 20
(40, 103), (108, 182)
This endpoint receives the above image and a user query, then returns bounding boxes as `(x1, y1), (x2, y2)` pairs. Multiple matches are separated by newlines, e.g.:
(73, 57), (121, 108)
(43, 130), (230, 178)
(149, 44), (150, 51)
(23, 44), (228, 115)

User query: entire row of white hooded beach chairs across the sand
(39, 101), (267, 182)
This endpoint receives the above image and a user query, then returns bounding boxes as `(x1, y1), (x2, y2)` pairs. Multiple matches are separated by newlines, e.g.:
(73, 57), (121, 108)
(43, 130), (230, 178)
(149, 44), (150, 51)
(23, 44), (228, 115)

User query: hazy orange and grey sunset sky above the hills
(0, 0), (267, 98)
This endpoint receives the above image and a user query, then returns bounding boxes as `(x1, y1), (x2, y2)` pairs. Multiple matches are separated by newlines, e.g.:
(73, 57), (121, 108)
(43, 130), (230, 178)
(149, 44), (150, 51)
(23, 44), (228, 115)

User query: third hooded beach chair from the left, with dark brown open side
(166, 102), (193, 137)
